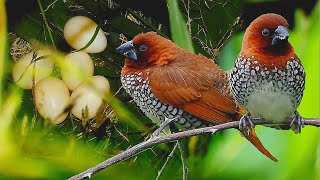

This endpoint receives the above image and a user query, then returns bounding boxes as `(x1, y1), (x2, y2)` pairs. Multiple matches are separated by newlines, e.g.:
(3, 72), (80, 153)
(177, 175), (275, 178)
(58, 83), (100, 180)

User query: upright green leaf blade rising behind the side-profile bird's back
(167, 0), (194, 52)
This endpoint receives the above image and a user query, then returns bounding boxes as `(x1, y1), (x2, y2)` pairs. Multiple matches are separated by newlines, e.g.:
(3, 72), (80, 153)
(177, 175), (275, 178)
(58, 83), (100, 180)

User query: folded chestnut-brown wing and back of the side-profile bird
(148, 50), (239, 124)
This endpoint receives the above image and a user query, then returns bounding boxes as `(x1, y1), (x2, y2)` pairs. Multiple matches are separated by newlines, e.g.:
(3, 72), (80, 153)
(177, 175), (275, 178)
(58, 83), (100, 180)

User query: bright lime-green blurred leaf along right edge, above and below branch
(288, 2), (320, 179)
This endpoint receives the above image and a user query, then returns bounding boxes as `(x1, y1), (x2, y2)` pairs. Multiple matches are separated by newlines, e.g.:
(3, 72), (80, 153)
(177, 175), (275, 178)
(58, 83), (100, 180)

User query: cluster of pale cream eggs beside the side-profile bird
(12, 16), (110, 124)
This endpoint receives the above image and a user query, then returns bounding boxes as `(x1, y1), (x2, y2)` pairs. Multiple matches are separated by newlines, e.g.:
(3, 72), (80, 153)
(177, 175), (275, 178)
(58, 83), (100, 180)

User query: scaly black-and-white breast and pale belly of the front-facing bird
(230, 56), (305, 122)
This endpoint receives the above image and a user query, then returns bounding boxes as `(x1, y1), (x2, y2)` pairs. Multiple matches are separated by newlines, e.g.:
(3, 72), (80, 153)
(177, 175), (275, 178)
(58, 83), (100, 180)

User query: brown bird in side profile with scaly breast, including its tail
(117, 32), (277, 161)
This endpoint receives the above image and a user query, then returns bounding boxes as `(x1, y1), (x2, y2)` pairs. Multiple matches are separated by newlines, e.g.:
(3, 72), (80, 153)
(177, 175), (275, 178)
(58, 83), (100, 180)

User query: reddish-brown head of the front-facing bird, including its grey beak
(241, 13), (293, 66)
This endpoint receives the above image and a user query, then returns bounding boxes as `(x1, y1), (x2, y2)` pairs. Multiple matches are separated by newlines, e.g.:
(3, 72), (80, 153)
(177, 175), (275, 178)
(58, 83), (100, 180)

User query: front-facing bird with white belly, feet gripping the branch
(229, 13), (306, 133)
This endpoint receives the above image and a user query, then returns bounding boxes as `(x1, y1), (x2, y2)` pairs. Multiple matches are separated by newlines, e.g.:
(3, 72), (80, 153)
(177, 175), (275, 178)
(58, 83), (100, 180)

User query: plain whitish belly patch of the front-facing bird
(246, 82), (295, 123)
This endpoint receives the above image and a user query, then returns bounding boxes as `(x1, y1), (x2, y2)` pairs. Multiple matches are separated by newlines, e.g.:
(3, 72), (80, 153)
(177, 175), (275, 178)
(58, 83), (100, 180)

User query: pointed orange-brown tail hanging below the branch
(241, 127), (278, 162)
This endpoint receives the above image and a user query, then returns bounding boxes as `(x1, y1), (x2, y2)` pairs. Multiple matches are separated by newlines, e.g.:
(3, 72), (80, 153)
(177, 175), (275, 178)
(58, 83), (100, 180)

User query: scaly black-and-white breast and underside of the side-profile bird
(121, 72), (207, 129)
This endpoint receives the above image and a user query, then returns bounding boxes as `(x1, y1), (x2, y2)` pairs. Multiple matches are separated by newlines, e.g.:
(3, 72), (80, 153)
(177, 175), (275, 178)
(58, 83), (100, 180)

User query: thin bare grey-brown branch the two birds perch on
(69, 118), (320, 180)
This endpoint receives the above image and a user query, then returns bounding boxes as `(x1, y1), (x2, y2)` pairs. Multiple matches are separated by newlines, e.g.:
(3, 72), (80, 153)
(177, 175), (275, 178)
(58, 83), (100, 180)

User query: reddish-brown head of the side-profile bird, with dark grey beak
(117, 32), (178, 71)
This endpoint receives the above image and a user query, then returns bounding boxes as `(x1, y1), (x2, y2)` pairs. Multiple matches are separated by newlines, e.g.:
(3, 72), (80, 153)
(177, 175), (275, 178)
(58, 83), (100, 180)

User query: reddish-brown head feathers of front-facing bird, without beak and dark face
(240, 13), (296, 68)
